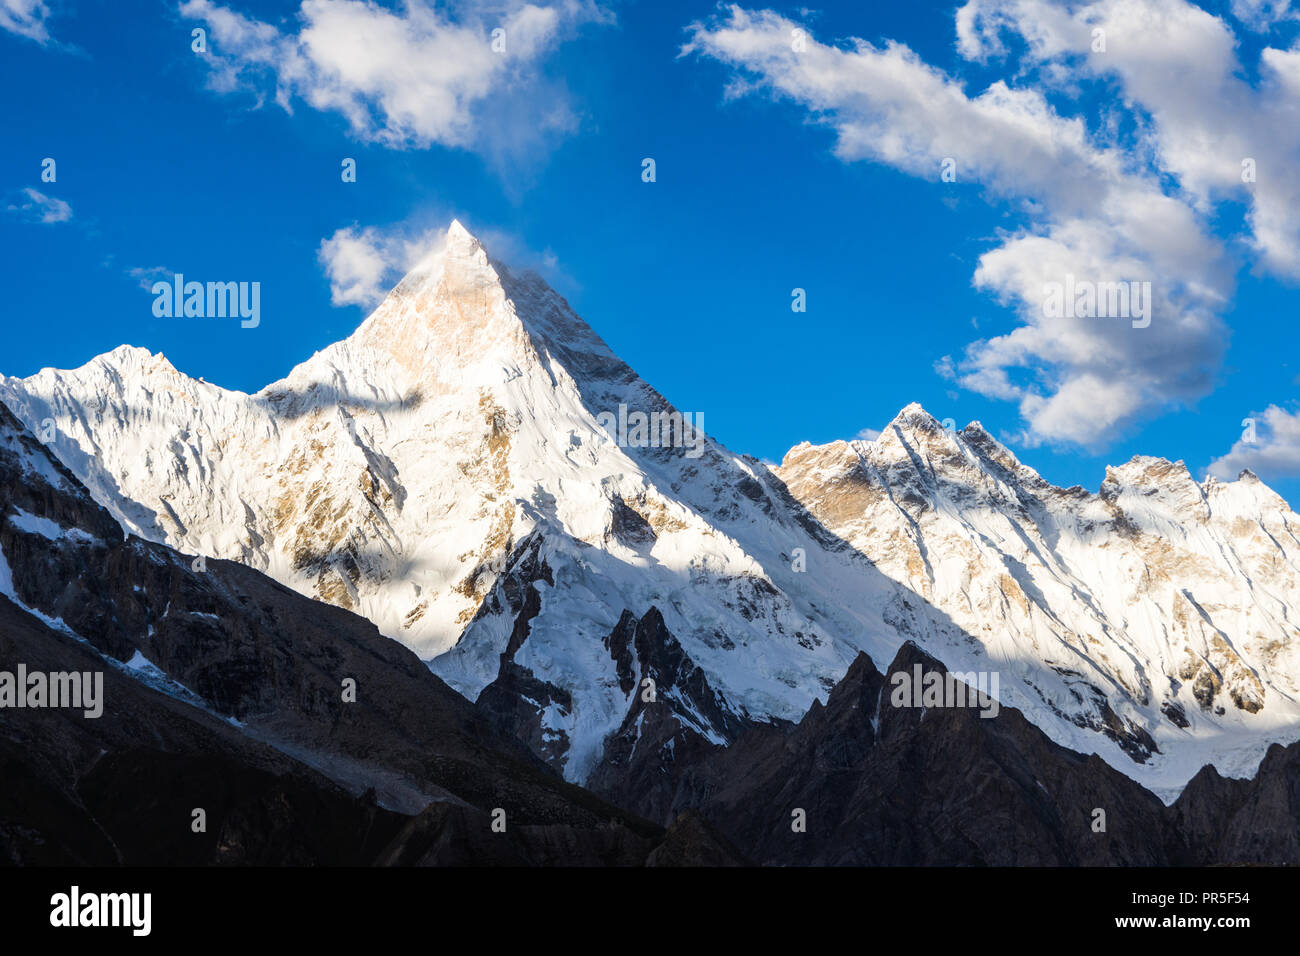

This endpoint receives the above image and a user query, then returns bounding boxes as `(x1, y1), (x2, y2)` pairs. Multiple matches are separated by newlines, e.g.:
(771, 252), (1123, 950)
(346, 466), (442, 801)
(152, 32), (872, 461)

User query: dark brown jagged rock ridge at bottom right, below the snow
(595, 634), (1300, 866)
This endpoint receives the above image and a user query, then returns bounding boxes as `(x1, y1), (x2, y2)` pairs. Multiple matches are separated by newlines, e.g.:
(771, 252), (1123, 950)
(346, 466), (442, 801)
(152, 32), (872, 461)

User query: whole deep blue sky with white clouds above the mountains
(0, 0), (1300, 503)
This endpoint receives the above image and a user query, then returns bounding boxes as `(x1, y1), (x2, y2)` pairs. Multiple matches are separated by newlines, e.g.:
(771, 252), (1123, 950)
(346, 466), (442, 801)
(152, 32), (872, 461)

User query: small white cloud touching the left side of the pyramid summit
(317, 225), (446, 308)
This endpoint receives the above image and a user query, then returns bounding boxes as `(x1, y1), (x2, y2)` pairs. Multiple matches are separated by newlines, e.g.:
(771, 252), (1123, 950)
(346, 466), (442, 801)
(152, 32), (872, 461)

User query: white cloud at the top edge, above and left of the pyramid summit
(179, 0), (608, 153)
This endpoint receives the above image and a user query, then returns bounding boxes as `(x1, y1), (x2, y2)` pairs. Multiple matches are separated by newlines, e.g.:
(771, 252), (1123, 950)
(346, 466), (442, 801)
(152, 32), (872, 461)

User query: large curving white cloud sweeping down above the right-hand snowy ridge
(683, 0), (1232, 445)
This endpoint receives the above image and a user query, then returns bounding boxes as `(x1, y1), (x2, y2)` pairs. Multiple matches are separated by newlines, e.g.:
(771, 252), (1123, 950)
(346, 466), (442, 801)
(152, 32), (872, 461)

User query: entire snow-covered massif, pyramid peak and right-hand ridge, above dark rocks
(0, 224), (1300, 792)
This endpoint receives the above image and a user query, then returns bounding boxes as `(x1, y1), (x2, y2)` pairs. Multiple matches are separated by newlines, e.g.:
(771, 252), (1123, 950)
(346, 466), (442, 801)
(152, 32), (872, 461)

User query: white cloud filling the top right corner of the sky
(959, 0), (1300, 280)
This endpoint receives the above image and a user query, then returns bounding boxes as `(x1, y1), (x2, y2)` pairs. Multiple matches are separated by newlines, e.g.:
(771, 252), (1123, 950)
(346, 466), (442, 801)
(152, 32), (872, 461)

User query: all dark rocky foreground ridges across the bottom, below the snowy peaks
(0, 405), (1300, 866)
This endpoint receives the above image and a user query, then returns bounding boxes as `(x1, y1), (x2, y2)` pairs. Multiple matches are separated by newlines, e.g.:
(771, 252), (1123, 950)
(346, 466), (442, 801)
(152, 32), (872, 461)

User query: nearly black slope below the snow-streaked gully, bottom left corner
(0, 598), (406, 865)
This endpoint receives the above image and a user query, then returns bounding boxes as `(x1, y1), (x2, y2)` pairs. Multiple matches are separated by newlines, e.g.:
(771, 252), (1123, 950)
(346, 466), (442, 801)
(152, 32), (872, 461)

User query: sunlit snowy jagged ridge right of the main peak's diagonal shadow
(776, 405), (1300, 796)
